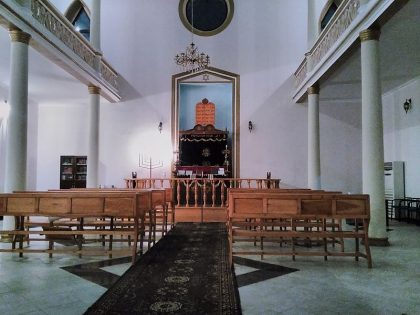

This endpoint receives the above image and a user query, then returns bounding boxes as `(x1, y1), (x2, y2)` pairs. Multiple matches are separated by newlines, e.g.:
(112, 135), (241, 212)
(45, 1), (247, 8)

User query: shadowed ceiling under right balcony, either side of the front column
(319, 0), (420, 127)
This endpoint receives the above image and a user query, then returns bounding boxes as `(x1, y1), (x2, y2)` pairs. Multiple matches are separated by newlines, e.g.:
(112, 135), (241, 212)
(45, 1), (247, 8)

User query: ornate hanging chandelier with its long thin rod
(175, 0), (210, 72)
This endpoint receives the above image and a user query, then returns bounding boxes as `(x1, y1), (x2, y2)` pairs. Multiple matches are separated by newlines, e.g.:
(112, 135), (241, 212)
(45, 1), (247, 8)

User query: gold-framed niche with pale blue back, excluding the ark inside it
(171, 67), (240, 177)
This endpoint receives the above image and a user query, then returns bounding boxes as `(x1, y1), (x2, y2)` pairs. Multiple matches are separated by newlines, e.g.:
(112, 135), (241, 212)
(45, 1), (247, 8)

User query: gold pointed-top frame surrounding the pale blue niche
(171, 67), (240, 178)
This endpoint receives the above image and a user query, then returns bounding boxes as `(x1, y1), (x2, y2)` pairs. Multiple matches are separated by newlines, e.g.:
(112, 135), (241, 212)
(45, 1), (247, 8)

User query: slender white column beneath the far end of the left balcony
(86, 85), (101, 188)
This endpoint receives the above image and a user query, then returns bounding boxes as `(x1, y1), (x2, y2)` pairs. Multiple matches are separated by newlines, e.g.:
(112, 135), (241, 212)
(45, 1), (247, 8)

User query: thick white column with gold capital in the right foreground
(360, 29), (389, 245)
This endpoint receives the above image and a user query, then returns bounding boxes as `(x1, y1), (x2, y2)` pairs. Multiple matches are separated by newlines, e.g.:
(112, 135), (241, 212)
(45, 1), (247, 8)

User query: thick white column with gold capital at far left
(3, 29), (30, 238)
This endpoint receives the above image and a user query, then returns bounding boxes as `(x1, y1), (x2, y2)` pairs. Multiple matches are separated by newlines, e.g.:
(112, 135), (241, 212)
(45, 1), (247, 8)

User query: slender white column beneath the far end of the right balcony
(308, 85), (321, 189)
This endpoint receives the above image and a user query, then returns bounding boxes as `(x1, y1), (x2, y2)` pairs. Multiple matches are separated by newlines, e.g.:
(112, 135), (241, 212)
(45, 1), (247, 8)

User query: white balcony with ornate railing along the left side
(0, 0), (121, 102)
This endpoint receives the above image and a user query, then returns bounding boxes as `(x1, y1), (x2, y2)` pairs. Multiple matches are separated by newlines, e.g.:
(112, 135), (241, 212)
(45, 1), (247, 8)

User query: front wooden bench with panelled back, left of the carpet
(0, 191), (152, 263)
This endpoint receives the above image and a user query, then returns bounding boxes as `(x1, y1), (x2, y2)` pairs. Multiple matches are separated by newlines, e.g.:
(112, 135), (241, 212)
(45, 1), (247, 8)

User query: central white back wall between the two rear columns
(95, 0), (307, 186)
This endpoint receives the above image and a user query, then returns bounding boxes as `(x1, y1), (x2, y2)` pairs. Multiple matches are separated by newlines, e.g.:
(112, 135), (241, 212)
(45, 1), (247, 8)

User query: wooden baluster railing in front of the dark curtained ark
(124, 178), (280, 208)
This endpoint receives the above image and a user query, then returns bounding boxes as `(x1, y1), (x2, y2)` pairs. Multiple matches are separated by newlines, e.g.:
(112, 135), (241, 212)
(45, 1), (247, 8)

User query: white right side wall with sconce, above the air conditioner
(382, 78), (420, 197)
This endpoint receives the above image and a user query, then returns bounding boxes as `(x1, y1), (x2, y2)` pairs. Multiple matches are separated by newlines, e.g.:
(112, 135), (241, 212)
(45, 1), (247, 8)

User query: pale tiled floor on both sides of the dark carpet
(0, 222), (420, 315)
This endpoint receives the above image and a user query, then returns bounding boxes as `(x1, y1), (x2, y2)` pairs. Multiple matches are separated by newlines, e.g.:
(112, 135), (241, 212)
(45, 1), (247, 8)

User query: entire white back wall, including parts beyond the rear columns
(29, 0), (370, 192)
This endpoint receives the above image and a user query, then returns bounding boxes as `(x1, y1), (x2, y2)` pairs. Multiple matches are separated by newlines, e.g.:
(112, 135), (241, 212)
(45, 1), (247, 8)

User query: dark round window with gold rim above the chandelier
(178, 0), (233, 36)
